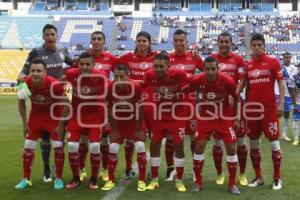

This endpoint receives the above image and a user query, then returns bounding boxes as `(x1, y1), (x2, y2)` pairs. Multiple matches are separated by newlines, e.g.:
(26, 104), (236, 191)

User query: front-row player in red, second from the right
(144, 52), (187, 192)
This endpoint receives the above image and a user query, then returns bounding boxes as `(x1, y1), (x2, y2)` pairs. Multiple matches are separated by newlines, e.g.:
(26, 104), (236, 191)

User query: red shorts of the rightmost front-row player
(195, 120), (236, 143)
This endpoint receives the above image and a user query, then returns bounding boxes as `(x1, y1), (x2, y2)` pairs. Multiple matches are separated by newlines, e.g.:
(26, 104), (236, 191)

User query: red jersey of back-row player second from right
(212, 52), (246, 83)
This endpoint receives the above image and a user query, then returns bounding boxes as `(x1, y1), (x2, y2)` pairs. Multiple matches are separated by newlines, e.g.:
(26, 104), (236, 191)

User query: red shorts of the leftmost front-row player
(26, 115), (61, 141)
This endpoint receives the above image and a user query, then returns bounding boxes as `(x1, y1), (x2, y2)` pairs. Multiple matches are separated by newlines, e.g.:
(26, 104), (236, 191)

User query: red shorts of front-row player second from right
(151, 127), (185, 144)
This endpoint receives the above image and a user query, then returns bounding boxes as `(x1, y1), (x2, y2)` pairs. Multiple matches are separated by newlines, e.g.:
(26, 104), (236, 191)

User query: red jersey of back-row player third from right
(169, 51), (203, 76)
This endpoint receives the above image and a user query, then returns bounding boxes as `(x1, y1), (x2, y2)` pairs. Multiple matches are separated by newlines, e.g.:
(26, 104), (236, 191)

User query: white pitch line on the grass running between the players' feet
(101, 151), (150, 200)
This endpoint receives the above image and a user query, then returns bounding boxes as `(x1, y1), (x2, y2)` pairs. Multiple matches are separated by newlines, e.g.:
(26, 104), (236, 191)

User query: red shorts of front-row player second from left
(67, 118), (102, 142)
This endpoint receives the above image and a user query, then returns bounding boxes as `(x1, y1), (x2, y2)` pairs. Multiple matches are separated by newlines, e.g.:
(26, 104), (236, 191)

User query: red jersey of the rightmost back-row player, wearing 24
(246, 54), (284, 108)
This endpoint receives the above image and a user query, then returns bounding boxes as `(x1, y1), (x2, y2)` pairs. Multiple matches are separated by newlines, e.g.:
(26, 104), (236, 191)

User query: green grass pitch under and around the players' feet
(0, 96), (300, 200)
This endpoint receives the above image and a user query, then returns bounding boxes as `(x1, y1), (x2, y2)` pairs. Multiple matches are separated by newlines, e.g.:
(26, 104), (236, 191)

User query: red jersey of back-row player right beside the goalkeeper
(72, 51), (117, 78)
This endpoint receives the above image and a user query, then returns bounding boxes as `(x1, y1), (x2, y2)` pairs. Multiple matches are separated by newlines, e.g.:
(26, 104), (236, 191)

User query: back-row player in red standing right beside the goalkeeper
(76, 31), (117, 181)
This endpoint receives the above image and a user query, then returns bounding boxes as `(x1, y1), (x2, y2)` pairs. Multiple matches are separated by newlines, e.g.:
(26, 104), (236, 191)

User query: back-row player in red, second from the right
(212, 32), (248, 186)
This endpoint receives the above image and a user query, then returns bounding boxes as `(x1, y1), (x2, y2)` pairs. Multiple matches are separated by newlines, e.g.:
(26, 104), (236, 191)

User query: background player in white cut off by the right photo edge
(289, 67), (300, 146)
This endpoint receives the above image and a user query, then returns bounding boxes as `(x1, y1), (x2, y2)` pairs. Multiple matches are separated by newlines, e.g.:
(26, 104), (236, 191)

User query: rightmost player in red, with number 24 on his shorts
(245, 34), (285, 190)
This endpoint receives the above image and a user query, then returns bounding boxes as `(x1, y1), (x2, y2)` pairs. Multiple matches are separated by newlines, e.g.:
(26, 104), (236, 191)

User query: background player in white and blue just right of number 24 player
(281, 52), (297, 141)
